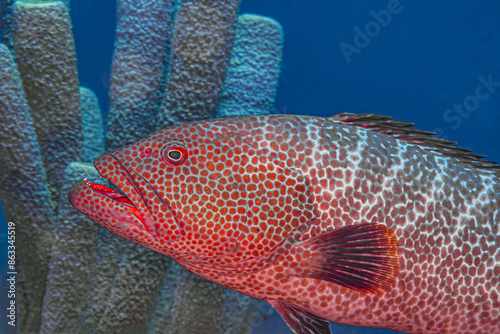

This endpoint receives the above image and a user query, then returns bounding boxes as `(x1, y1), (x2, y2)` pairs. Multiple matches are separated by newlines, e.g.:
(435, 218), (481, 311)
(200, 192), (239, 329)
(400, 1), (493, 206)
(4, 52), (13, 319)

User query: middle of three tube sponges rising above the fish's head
(157, 0), (239, 129)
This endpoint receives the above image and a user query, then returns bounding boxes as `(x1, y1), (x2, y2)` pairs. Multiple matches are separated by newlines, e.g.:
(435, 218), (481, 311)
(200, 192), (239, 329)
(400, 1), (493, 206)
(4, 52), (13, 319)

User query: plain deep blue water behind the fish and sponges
(0, 0), (500, 334)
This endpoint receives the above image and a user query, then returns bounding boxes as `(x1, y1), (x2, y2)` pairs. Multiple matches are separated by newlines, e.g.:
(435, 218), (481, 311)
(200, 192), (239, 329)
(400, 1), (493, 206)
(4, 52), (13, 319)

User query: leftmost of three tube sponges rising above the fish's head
(106, 0), (175, 150)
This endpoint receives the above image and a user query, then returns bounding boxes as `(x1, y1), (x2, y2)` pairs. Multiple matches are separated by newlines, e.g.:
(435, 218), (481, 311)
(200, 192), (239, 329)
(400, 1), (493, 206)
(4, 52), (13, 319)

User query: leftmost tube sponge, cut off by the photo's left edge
(0, 44), (55, 333)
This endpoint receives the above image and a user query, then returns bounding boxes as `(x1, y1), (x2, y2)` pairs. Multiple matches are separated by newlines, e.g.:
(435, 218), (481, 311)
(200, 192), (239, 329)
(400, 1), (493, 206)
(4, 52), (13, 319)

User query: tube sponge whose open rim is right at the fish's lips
(39, 162), (99, 334)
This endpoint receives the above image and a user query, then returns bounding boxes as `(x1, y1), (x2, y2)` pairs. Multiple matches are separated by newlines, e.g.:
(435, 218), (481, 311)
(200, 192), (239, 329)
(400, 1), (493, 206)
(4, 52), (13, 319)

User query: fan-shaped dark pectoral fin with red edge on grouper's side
(292, 223), (399, 293)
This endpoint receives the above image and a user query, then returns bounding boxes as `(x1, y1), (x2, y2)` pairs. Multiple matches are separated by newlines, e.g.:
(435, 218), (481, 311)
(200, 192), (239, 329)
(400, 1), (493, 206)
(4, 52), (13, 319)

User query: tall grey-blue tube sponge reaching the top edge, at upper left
(13, 1), (83, 202)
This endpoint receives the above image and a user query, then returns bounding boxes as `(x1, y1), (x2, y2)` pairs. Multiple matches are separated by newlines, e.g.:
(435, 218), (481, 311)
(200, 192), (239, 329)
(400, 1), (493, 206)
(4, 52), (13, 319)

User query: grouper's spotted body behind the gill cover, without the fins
(174, 116), (500, 333)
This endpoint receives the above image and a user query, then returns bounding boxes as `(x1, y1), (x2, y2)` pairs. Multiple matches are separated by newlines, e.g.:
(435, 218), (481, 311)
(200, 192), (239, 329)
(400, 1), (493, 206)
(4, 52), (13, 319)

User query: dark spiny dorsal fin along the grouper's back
(330, 113), (500, 177)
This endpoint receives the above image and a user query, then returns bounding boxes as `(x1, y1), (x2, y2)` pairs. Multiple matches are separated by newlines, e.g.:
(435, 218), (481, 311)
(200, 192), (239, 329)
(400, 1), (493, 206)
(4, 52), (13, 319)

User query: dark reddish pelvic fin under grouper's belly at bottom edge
(269, 301), (331, 334)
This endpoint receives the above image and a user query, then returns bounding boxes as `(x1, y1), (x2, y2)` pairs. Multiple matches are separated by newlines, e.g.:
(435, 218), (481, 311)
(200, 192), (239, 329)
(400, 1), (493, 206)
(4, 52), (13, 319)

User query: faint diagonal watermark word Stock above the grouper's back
(434, 74), (500, 139)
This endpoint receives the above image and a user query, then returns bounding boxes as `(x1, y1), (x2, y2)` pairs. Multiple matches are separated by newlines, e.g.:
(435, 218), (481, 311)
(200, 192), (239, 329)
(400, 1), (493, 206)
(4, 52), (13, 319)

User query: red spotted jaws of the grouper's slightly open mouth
(69, 152), (183, 257)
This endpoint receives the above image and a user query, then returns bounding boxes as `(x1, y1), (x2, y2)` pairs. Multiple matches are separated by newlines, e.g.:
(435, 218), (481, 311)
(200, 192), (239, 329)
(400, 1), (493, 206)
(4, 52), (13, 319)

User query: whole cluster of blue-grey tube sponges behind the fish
(0, 0), (282, 334)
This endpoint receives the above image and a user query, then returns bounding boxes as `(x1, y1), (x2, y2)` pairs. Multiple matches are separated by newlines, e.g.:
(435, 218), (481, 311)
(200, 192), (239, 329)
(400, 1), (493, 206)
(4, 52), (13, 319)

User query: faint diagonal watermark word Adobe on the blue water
(339, 0), (411, 64)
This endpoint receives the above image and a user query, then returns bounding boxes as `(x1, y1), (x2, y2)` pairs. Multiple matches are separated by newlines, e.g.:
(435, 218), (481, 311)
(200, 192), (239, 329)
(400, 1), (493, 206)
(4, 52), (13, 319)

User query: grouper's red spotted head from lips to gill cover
(69, 120), (314, 269)
